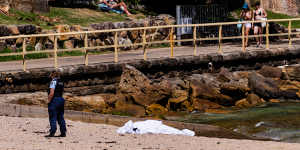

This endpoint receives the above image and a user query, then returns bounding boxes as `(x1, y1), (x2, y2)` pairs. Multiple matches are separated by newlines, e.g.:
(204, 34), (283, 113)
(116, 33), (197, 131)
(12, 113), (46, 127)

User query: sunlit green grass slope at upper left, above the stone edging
(0, 7), (145, 29)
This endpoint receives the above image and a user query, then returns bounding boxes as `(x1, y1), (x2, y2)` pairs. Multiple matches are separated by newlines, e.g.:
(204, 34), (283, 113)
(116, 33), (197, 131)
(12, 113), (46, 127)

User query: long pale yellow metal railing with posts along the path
(0, 18), (300, 71)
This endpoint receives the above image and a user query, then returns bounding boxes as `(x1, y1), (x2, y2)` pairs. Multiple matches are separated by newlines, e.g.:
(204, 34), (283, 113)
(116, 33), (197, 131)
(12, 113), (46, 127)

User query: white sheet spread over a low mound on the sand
(117, 120), (195, 136)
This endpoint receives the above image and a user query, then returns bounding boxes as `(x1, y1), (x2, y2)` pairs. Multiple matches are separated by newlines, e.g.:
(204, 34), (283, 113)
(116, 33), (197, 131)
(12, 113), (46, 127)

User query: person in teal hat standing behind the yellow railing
(240, 3), (252, 47)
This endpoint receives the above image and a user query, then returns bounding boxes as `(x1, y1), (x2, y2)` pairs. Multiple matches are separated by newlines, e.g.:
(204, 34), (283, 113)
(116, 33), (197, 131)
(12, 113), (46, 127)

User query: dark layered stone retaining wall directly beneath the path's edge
(0, 49), (300, 95)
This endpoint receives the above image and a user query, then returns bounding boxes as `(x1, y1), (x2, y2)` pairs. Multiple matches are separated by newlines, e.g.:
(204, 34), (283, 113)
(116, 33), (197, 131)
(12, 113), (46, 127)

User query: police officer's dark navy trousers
(48, 97), (67, 134)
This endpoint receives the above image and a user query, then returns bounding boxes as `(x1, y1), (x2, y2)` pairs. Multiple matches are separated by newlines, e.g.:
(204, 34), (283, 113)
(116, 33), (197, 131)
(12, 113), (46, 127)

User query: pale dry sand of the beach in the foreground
(0, 116), (300, 150)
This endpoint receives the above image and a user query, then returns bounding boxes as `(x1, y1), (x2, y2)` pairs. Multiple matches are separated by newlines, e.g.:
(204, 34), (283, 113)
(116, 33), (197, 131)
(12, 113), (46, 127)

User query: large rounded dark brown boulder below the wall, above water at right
(248, 72), (282, 99)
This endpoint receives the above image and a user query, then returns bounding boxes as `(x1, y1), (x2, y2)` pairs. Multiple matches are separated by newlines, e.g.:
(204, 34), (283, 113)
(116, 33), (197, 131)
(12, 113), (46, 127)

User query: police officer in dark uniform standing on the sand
(46, 71), (67, 137)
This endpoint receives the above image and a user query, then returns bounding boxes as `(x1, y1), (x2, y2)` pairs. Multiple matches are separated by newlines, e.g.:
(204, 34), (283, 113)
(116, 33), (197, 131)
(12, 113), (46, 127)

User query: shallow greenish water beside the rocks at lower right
(177, 101), (300, 143)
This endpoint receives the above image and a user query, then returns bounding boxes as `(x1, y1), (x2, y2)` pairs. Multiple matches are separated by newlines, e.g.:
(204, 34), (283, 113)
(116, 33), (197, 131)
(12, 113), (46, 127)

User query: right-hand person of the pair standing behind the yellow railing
(253, 2), (267, 47)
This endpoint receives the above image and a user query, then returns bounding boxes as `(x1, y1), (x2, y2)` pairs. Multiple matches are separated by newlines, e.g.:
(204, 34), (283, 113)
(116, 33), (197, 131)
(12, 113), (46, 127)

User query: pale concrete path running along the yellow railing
(0, 42), (300, 72)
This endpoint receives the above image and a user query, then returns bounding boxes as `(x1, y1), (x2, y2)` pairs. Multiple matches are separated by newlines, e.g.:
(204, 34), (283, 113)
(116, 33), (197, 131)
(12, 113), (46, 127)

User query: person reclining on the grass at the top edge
(97, 0), (131, 16)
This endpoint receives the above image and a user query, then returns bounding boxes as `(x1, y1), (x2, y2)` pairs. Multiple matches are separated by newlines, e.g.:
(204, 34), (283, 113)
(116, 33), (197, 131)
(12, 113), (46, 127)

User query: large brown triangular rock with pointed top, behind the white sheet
(119, 65), (171, 106)
